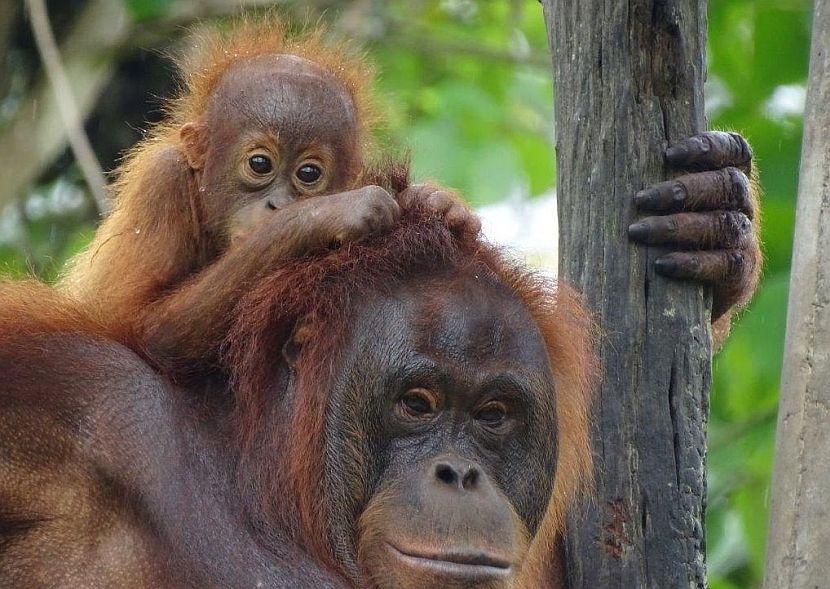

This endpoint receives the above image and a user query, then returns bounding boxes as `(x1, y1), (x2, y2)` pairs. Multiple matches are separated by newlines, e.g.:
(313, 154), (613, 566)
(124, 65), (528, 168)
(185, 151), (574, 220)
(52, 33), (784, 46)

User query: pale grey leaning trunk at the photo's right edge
(764, 0), (830, 589)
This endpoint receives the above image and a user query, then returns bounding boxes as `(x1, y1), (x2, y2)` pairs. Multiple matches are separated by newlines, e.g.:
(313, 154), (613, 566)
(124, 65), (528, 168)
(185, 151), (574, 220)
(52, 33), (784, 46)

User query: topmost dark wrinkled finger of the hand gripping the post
(666, 131), (752, 173)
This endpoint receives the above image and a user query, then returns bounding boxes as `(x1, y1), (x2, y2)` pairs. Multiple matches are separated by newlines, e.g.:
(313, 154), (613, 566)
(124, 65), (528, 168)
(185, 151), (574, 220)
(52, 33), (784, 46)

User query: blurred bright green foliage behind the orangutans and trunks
(0, 0), (811, 589)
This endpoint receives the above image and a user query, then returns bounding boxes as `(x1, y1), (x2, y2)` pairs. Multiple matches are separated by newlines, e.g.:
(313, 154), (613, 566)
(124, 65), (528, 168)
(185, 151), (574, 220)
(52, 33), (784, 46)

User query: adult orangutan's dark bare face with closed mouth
(326, 277), (556, 589)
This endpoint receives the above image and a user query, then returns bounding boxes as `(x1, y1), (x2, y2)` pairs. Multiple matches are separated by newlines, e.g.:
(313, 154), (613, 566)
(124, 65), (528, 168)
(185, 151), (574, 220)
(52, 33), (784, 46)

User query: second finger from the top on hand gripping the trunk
(634, 167), (755, 219)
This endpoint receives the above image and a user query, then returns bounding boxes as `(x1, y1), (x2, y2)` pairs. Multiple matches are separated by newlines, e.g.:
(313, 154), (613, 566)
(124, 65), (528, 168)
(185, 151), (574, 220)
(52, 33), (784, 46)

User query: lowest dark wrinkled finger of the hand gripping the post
(654, 250), (752, 284)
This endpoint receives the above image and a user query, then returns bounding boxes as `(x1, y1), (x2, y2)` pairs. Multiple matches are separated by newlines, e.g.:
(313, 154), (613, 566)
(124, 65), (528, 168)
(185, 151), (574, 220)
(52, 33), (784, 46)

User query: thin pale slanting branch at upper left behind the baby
(26, 0), (109, 215)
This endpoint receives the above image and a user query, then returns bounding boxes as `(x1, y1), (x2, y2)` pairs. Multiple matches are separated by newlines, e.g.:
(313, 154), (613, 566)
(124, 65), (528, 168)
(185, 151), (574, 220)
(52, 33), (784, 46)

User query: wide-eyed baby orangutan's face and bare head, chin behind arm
(181, 55), (361, 246)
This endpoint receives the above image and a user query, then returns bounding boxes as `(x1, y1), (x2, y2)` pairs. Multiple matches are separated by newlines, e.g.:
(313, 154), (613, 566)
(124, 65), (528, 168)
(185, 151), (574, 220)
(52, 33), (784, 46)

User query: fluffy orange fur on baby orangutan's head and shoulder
(60, 15), (376, 327)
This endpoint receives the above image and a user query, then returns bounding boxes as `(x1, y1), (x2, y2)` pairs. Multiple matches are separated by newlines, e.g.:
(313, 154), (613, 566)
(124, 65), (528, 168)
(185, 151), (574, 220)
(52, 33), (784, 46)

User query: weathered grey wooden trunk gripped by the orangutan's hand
(543, 0), (711, 589)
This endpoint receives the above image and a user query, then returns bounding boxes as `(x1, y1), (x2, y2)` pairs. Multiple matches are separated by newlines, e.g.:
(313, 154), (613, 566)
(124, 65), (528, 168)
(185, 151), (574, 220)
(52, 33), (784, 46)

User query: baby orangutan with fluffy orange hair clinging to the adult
(62, 20), (479, 373)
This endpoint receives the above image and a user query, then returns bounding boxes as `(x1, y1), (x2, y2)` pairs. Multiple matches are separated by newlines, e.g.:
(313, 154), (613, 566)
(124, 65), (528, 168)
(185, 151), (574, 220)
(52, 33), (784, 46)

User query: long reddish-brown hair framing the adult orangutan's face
(225, 171), (597, 587)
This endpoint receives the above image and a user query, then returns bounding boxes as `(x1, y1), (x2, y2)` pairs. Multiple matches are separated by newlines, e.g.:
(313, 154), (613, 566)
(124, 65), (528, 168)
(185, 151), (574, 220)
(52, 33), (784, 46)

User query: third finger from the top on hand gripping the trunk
(628, 211), (752, 250)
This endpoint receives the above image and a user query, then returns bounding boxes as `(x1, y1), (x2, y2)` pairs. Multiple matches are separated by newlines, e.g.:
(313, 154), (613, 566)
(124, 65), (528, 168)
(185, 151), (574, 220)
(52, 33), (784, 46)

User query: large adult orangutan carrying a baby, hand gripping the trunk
(0, 127), (755, 589)
